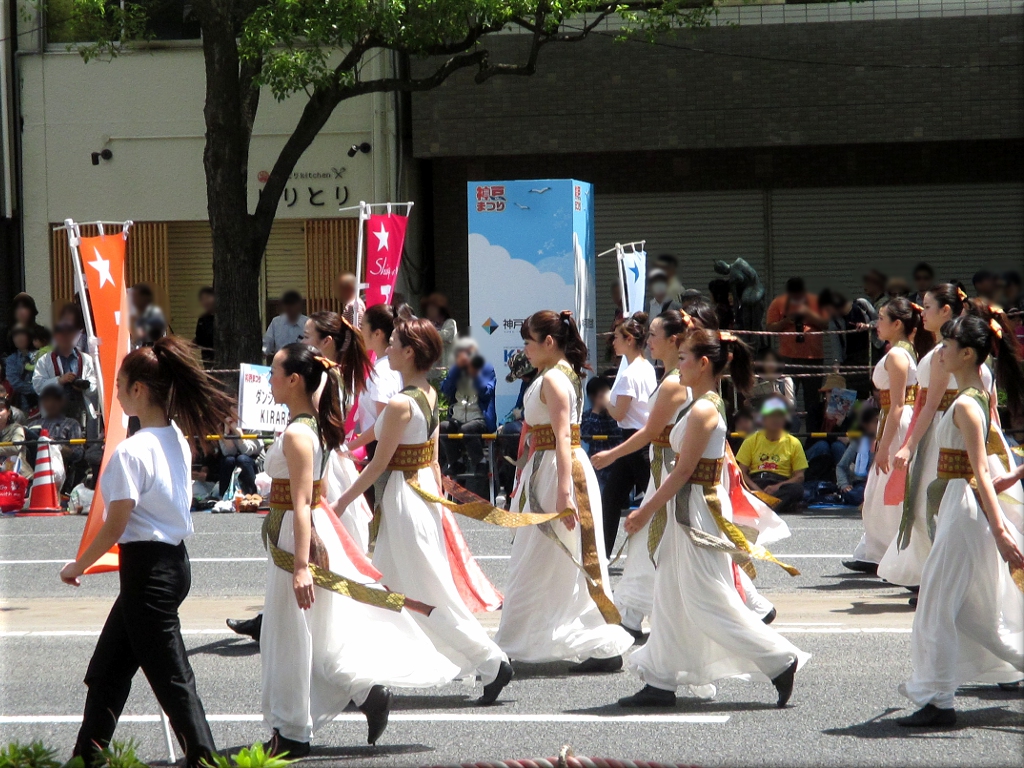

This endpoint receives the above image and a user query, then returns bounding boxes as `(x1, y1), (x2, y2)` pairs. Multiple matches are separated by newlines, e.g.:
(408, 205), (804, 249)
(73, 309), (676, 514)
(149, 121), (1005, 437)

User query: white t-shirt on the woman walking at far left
(99, 424), (193, 546)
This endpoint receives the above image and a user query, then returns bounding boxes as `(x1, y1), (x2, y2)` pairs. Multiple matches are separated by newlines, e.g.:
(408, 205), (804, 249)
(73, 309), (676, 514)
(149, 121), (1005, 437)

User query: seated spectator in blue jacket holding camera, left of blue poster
(440, 337), (497, 489)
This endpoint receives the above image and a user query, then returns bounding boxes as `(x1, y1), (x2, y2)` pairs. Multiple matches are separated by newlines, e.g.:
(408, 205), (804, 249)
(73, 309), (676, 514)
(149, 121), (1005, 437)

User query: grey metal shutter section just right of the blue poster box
(594, 189), (765, 331)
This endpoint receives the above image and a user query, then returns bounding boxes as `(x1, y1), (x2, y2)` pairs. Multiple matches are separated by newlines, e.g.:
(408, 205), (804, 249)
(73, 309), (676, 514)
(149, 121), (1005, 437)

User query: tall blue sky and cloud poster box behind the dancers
(467, 179), (597, 422)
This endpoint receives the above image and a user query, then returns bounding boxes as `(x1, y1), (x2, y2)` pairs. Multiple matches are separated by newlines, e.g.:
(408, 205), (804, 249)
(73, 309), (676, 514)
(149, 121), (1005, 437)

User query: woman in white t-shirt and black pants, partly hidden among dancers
(601, 312), (657, 557)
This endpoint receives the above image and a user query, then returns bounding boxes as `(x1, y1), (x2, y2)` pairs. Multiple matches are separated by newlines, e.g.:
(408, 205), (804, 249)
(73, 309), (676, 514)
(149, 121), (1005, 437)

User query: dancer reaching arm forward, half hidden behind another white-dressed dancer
(590, 309), (693, 641)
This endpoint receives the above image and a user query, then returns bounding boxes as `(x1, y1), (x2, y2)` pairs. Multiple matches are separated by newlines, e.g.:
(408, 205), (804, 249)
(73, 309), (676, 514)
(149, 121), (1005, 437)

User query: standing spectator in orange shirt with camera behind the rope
(766, 278), (828, 432)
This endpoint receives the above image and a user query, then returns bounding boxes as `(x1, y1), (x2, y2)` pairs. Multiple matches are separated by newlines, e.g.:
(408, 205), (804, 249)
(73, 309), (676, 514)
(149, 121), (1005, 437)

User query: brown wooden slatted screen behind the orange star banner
(50, 221), (171, 322)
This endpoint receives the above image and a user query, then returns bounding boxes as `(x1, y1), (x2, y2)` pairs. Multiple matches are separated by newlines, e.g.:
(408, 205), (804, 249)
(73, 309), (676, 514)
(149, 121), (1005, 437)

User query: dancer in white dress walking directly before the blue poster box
(495, 310), (633, 673)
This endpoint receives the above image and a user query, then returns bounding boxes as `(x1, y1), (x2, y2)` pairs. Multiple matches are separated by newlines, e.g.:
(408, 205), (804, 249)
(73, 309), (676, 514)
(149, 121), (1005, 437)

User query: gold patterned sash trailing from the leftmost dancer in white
(262, 507), (433, 615)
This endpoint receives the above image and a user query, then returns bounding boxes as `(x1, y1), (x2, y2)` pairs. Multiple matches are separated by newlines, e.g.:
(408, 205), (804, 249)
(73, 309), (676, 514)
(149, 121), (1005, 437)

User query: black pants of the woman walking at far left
(75, 542), (215, 767)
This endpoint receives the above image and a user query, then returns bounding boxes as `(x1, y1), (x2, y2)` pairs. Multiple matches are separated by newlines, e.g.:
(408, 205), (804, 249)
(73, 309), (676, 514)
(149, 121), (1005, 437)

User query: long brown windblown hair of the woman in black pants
(121, 336), (234, 448)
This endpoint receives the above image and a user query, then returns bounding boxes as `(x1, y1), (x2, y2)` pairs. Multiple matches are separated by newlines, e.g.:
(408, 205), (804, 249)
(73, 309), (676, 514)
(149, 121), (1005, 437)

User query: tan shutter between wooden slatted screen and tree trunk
(167, 221), (213, 339)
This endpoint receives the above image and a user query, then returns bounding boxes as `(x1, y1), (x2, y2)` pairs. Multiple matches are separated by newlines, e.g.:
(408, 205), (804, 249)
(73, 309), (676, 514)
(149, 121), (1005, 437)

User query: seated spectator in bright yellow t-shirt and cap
(736, 397), (807, 512)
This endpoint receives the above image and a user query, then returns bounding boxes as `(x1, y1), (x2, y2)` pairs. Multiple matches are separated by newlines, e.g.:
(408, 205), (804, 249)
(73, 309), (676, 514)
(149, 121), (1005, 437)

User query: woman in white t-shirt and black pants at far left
(60, 336), (232, 768)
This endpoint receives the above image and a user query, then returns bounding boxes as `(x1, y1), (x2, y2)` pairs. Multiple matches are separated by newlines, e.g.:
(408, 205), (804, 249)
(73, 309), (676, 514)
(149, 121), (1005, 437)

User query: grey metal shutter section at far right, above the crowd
(771, 183), (1024, 296)
